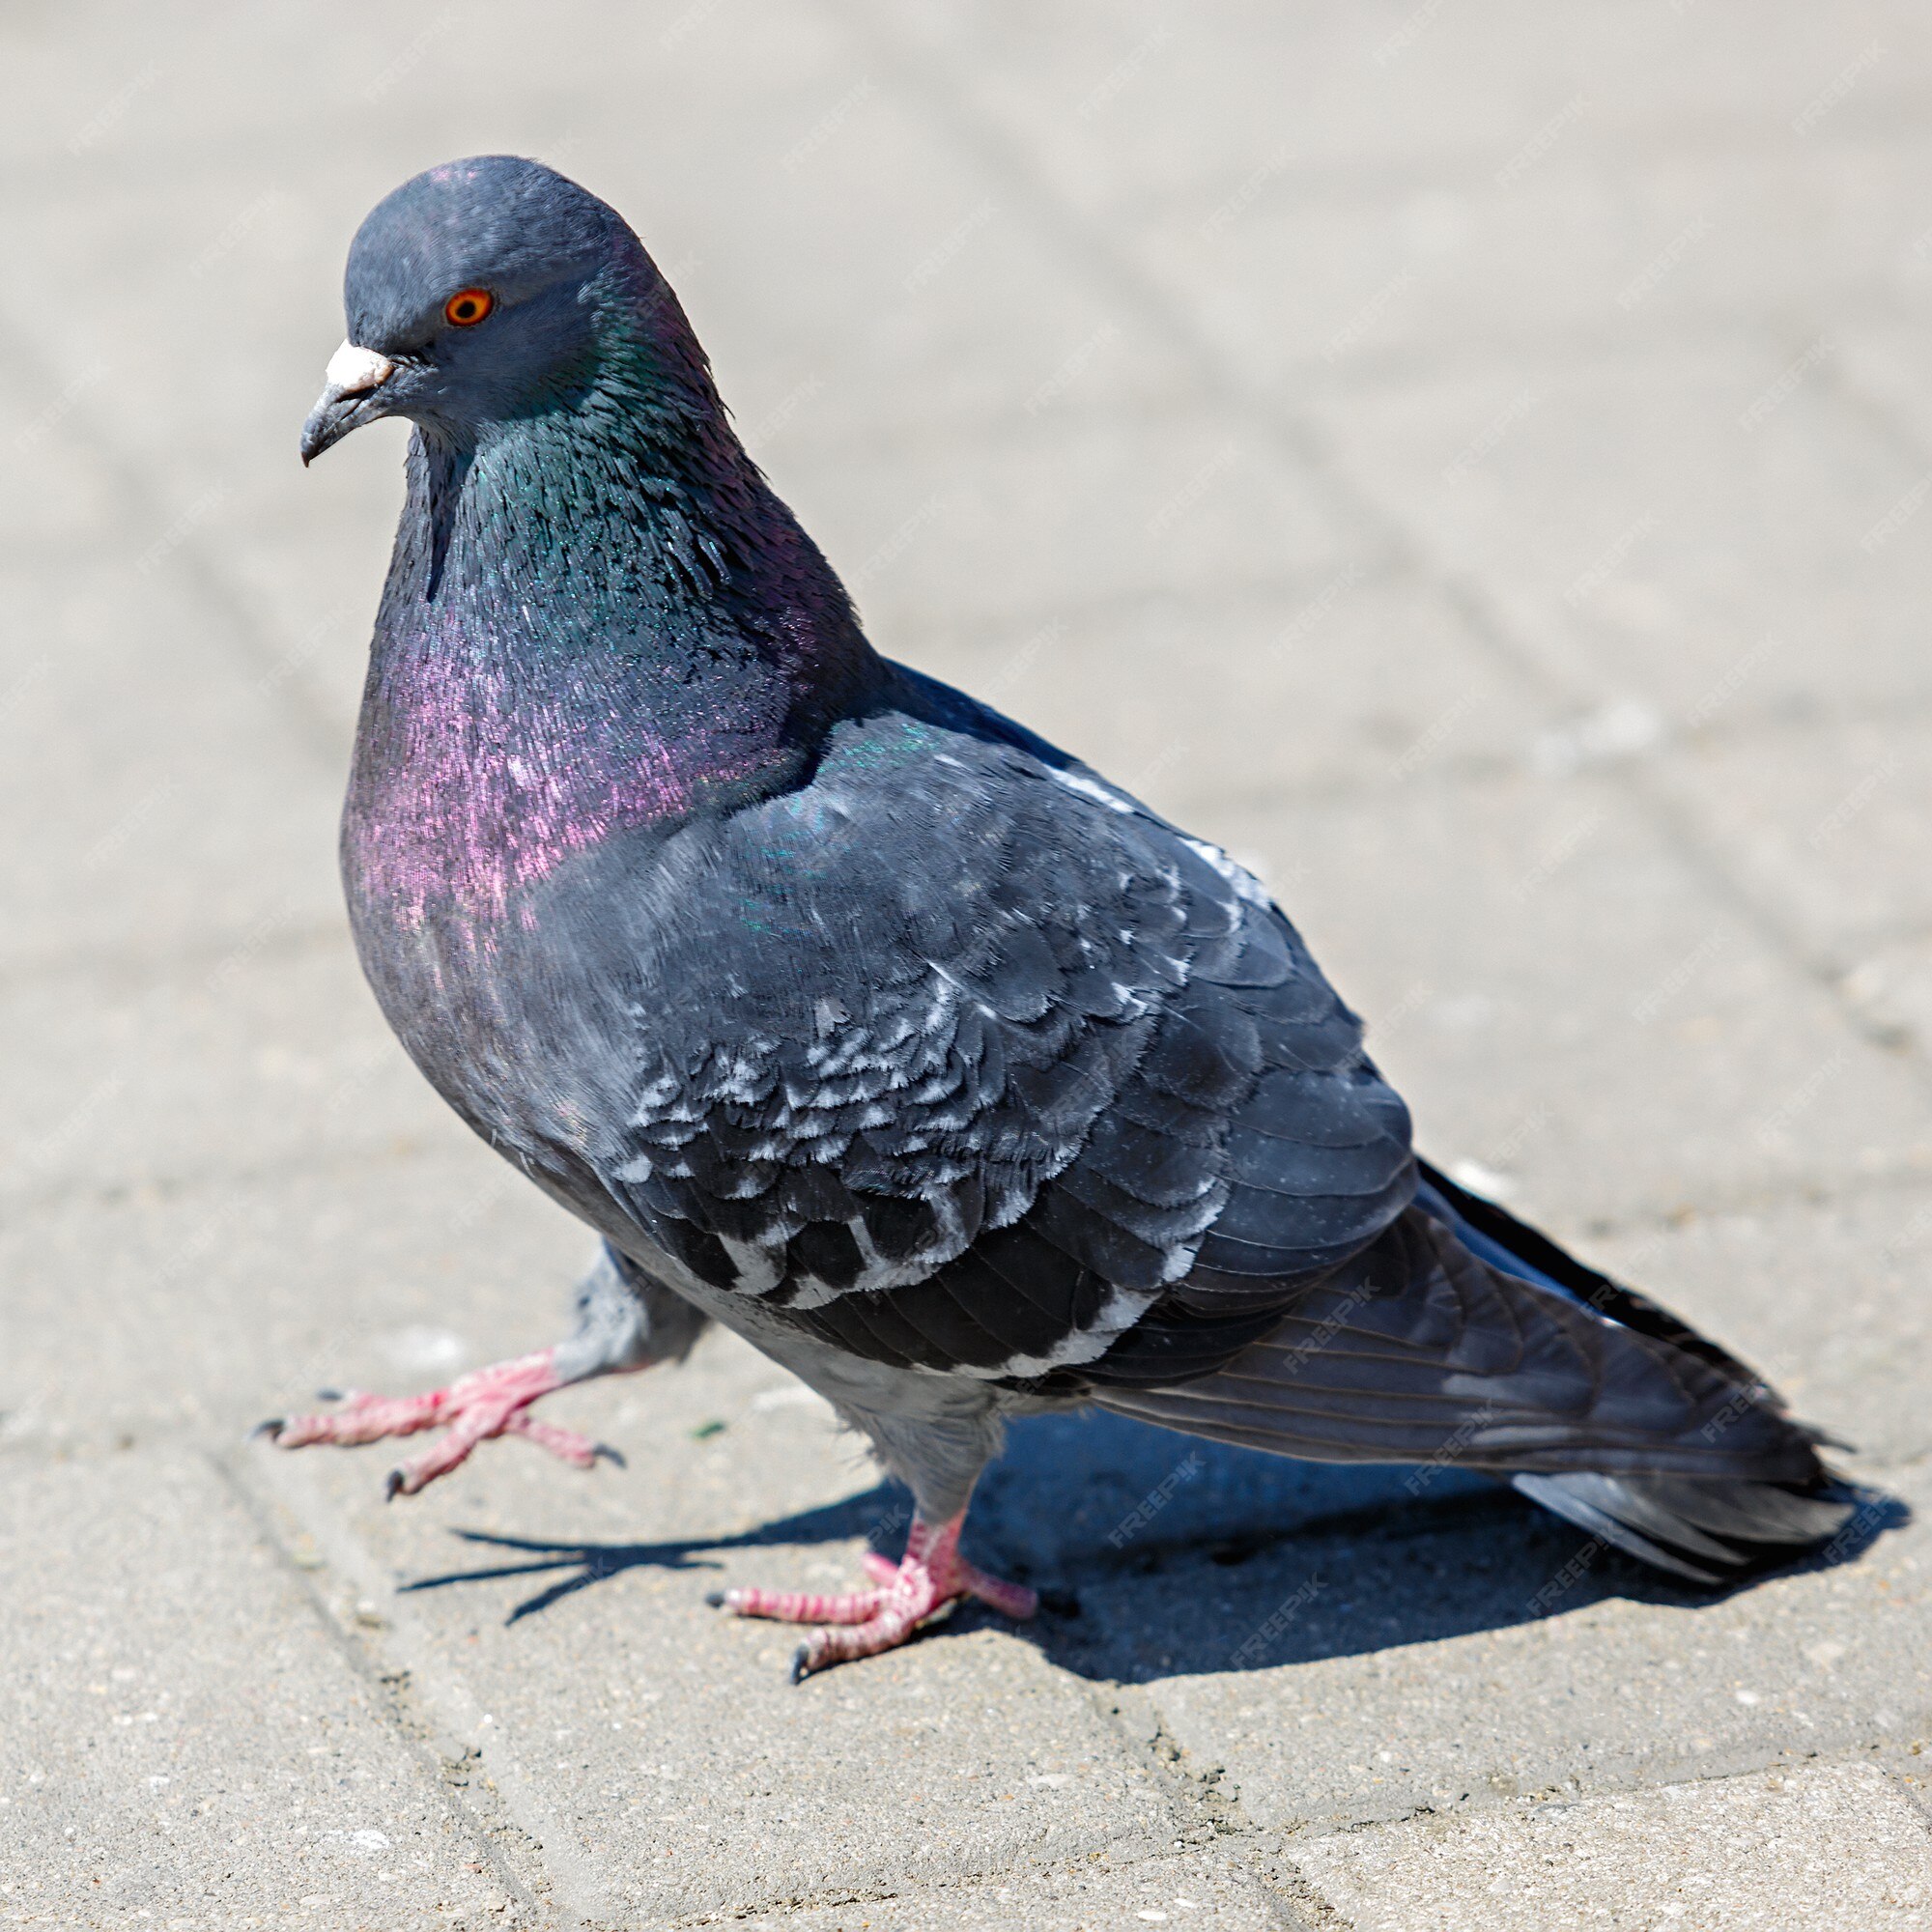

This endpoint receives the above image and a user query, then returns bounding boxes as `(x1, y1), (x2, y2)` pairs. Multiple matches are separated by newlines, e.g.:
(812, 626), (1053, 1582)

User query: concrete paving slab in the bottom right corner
(1294, 1764), (1932, 1932)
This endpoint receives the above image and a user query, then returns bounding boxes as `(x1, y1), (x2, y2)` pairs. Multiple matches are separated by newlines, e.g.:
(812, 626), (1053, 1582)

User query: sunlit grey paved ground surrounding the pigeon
(0, 0), (1932, 1932)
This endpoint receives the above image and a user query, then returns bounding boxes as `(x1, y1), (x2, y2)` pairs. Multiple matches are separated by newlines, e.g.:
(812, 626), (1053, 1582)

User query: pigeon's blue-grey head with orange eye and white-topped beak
(301, 155), (701, 464)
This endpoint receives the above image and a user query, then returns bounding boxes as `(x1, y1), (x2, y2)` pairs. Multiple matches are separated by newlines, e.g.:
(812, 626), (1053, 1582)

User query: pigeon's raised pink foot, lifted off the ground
(255, 1349), (622, 1497)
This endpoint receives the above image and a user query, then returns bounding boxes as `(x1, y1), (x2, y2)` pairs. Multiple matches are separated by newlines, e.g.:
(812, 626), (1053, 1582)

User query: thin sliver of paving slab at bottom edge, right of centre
(746, 1855), (1291, 1932)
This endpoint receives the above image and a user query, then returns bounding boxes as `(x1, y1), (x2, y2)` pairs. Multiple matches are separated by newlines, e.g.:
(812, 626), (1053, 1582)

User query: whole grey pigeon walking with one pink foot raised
(263, 155), (1851, 1681)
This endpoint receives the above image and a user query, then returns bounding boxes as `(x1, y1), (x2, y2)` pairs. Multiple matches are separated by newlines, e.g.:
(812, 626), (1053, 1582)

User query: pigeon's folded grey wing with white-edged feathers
(601, 686), (1414, 1381)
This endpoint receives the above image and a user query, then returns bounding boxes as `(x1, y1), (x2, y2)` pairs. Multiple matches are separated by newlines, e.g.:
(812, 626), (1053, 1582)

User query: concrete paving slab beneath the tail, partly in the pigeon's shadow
(1090, 1470), (1932, 1832)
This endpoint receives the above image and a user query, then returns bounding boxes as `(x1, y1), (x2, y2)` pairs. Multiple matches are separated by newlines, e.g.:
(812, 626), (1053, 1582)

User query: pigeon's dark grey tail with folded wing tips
(1092, 1167), (1853, 1582)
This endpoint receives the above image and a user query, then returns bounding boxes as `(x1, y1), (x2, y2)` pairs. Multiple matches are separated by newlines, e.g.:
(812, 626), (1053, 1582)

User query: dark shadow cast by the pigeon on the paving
(404, 1416), (1909, 1683)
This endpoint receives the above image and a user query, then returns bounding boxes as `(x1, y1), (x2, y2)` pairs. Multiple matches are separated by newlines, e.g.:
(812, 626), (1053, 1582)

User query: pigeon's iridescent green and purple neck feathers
(342, 384), (879, 937)
